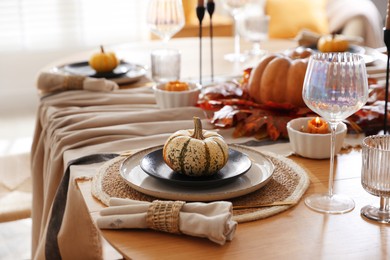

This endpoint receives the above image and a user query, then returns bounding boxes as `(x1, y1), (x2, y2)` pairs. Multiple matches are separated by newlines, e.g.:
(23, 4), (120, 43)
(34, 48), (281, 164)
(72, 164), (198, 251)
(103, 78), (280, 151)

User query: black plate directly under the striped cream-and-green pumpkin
(140, 148), (252, 188)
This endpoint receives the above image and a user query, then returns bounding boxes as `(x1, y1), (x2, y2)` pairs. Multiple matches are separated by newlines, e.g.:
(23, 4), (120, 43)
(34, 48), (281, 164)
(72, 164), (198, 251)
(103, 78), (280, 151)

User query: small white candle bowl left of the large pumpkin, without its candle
(153, 82), (201, 109)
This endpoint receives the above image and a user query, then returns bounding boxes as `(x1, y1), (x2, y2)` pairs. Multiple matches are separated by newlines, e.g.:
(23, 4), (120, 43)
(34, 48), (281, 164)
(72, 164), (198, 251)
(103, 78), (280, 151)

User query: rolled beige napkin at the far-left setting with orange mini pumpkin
(37, 72), (119, 94)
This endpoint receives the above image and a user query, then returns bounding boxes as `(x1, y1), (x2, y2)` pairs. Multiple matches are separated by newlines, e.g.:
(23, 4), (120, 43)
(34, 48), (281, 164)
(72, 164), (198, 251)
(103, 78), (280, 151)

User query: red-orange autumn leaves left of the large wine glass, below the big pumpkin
(199, 70), (312, 140)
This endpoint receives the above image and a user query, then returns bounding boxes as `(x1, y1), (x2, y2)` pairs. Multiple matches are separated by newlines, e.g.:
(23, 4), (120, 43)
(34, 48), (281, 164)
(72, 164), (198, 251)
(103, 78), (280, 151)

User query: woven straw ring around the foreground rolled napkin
(146, 200), (185, 234)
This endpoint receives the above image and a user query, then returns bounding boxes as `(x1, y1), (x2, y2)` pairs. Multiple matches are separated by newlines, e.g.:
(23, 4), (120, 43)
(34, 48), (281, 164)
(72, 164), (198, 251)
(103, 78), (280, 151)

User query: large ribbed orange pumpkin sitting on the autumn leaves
(247, 49), (312, 107)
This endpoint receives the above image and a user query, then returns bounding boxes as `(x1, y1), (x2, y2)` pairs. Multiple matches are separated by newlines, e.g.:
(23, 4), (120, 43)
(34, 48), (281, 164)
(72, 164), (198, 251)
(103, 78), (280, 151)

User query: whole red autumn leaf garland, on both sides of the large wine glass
(199, 69), (390, 140)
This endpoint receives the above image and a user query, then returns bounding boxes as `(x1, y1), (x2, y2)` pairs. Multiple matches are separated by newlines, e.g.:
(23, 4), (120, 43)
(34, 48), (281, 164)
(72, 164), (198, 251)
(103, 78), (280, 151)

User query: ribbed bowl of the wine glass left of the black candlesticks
(147, 0), (185, 43)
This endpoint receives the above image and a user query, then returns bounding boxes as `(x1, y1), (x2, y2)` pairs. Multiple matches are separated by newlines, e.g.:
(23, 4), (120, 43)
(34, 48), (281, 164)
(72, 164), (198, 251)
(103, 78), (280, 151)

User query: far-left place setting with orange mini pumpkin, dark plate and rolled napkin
(37, 46), (147, 96)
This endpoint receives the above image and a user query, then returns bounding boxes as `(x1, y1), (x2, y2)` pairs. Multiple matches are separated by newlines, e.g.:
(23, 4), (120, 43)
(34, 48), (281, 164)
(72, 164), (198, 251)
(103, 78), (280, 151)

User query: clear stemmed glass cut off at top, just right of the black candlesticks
(222, 0), (252, 62)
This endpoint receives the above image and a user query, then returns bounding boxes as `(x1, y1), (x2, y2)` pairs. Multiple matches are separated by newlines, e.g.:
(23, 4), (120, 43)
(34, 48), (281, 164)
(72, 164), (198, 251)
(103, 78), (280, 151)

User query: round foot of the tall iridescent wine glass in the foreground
(305, 194), (355, 214)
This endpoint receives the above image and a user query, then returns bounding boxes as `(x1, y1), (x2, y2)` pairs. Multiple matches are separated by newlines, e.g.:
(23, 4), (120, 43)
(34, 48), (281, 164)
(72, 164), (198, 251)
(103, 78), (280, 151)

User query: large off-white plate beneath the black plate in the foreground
(120, 145), (275, 201)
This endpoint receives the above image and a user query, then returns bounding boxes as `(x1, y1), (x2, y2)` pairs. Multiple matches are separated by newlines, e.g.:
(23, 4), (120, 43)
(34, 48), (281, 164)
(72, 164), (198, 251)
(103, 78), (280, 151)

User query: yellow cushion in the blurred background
(266, 0), (329, 38)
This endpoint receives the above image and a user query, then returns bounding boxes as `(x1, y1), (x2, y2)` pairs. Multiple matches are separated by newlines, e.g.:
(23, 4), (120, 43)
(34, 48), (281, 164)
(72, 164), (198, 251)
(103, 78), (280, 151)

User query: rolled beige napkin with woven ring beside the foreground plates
(97, 198), (237, 245)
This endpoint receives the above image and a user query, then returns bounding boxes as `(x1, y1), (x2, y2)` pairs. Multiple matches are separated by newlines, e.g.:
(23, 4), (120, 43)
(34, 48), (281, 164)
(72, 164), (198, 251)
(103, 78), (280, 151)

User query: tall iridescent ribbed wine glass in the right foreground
(302, 52), (368, 214)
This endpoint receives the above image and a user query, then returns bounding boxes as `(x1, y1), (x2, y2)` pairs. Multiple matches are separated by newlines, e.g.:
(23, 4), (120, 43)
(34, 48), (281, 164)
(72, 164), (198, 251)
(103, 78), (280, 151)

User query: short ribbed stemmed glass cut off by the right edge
(360, 135), (390, 223)
